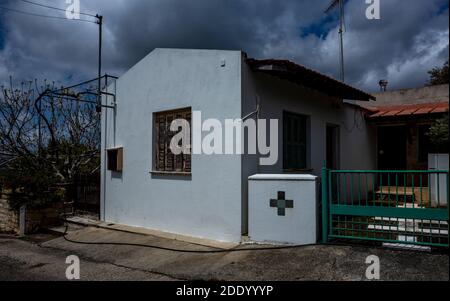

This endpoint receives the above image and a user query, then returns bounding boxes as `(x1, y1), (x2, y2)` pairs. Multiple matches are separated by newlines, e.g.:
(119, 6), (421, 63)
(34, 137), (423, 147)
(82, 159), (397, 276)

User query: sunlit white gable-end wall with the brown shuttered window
(101, 49), (242, 242)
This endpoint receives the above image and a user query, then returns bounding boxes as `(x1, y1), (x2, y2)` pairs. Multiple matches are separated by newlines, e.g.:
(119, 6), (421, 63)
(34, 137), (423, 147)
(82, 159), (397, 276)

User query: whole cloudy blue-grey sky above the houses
(0, 0), (449, 91)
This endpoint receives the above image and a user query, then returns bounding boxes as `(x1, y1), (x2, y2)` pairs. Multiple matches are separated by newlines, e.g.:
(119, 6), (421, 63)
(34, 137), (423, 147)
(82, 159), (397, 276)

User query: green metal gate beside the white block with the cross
(322, 168), (449, 247)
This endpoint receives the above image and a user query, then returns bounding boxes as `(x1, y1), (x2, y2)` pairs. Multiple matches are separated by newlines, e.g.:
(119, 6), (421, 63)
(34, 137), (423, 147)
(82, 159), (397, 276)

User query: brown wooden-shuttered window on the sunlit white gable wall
(153, 108), (192, 173)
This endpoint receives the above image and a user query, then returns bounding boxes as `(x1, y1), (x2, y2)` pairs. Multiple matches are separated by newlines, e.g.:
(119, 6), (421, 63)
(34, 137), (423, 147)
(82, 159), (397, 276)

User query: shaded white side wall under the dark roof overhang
(243, 73), (376, 176)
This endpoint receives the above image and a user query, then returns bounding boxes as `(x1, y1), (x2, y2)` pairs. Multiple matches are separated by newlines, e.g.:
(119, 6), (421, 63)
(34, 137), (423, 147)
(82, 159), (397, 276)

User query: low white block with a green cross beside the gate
(248, 174), (317, 245)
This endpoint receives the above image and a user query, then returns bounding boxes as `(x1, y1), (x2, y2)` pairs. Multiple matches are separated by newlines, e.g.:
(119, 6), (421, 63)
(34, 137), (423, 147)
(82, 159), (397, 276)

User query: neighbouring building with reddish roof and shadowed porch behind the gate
(358, 84), (449, 170)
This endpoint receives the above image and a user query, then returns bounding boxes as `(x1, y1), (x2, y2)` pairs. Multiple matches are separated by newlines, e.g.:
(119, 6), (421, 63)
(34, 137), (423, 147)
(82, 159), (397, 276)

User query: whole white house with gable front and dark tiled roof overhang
(101, 49), (376, 242)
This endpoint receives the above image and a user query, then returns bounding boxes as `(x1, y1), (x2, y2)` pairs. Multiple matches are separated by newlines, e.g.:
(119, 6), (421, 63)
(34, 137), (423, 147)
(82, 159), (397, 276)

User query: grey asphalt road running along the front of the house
(0, 227), (449, 281)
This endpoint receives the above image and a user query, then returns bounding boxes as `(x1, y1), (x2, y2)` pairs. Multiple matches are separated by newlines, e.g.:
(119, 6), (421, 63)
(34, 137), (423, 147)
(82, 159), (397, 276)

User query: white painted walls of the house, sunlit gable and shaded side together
(101, 49), (376, 242)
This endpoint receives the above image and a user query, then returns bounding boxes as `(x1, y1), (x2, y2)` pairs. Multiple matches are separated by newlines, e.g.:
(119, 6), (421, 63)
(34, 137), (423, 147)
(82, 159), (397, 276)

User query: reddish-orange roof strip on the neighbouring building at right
(369, 102), (449, 119)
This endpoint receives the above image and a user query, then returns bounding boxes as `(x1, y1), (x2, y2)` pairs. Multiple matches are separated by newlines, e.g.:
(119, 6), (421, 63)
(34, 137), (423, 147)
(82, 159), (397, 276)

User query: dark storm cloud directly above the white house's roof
(98, 0), (321, 70)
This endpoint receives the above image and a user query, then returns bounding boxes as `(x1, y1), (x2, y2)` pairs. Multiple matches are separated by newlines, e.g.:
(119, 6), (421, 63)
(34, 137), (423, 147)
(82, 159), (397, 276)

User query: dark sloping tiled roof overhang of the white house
(247, 59), (376, 101)
